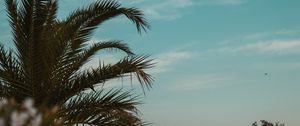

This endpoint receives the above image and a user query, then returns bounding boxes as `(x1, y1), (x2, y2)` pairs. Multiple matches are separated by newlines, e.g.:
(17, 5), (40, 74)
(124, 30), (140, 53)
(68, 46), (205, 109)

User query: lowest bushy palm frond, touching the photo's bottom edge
(61, 90), (140, 126)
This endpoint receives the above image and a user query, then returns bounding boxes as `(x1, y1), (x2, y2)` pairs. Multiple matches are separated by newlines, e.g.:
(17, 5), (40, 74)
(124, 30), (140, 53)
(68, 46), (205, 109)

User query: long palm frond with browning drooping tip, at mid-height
(51, 56), (153, 103)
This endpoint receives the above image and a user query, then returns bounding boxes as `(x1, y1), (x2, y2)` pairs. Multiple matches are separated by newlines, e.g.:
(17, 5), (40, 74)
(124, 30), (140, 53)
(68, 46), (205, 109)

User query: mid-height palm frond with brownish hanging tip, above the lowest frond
(67, 56), (153, 95)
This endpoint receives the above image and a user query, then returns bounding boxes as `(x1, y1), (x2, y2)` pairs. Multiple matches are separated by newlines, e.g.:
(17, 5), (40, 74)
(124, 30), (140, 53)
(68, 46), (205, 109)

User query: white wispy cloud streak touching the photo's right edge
(219, 39), (300, 54)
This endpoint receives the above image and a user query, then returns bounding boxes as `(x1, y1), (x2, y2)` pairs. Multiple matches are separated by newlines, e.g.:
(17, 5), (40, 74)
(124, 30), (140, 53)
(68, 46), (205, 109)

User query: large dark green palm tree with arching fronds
(0, 0), (153, 126)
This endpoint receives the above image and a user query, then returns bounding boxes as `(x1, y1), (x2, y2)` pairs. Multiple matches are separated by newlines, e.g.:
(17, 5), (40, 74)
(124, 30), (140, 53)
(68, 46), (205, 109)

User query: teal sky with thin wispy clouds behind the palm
(0, 0), (300, 126)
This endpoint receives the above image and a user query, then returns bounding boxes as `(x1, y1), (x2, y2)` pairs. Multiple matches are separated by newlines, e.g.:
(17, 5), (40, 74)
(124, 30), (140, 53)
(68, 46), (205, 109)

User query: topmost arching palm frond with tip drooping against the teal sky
(62, 0), (149, 49)
